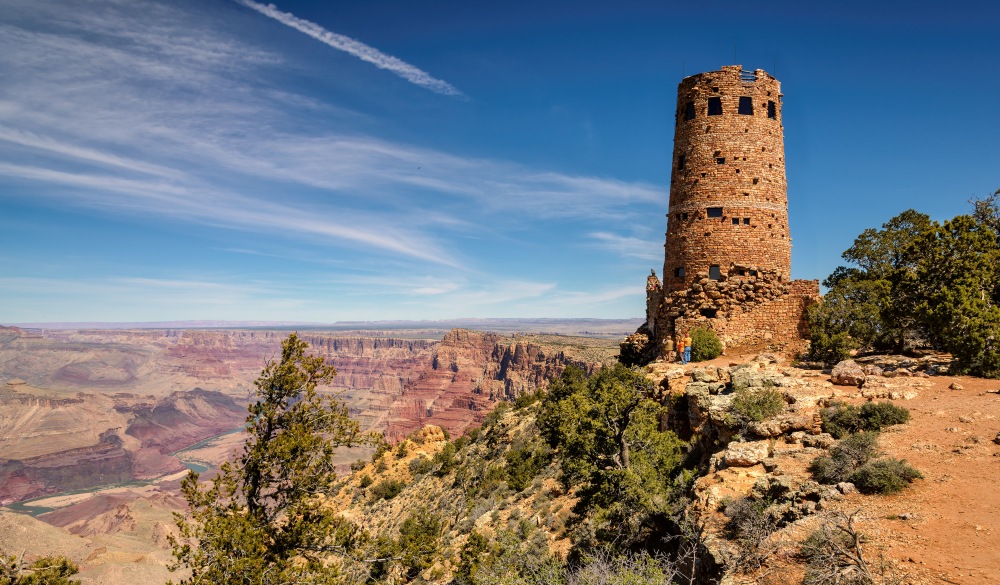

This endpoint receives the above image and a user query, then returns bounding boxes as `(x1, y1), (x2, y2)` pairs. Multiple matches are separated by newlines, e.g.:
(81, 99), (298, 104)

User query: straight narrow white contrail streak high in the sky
(233, 0), (465, 97)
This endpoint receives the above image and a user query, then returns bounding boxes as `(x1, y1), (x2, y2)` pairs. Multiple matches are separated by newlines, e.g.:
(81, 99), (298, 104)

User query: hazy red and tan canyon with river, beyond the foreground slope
(0, 323), (623, 583)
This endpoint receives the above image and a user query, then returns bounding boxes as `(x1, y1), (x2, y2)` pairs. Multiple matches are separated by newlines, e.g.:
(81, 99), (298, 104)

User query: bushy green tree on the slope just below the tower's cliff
(538, 364), (682, 546)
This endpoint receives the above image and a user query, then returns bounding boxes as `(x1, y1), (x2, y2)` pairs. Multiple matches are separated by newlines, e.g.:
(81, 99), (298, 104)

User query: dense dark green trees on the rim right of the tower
(809, 191), (1000, 377)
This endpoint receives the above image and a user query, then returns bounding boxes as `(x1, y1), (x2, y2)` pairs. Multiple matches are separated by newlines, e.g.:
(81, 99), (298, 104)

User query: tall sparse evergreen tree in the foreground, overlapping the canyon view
(171, 333), (376, 585)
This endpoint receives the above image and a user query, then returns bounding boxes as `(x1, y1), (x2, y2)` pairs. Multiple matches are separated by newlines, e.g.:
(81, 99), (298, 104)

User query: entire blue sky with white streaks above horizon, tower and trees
(0, 0), (1000, 323)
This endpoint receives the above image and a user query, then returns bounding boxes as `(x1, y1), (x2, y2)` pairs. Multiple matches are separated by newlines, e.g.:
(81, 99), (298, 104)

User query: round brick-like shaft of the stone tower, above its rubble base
(663, 65), (791, 292)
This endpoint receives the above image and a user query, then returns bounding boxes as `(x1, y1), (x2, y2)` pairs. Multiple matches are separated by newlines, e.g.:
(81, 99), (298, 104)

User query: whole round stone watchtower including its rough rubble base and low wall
(644, 65), (819, 354)
